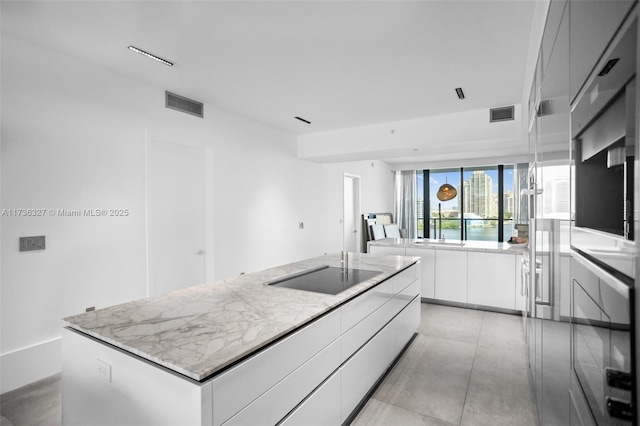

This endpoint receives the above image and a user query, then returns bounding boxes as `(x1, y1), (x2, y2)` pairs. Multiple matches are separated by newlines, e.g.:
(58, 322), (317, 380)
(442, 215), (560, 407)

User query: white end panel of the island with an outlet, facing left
(62, 328), (213, 426)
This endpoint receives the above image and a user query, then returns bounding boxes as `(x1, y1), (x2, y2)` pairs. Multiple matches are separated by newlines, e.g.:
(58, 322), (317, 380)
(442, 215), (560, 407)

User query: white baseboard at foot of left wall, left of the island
(0, 337), (62, 394)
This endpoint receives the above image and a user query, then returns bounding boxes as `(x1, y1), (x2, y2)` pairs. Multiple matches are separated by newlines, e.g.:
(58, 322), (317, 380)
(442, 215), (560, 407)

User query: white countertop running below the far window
(369, 238), (528, 254)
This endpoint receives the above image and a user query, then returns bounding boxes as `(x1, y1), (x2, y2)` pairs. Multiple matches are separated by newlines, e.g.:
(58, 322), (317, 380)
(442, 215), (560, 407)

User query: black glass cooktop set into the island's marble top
(266, 265), (382, 295)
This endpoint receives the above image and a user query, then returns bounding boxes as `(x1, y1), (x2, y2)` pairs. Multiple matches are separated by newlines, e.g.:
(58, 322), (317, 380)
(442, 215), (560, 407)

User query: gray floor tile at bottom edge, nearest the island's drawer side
(351, 398), (453, 426)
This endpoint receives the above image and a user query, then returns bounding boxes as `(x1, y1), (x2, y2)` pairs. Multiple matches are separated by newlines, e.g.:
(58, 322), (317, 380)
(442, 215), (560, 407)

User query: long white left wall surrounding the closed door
(0, 35), (340, 392)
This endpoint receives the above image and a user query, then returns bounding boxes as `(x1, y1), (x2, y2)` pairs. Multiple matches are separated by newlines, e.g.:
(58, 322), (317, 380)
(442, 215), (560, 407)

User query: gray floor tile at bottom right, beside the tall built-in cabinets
(461, 345), (536, 426)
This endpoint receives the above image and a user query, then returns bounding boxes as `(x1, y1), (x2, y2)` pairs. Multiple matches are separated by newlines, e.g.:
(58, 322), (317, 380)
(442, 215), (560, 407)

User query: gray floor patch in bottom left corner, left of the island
(0, 374), (61, 426)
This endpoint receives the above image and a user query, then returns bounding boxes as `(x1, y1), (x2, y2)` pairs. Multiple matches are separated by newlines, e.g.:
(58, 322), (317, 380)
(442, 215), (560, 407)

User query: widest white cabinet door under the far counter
(467, 252), (516, 309)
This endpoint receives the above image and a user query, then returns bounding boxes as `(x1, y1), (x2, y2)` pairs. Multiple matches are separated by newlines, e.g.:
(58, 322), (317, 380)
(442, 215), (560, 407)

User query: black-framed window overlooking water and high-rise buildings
(416, 165), (518, 241)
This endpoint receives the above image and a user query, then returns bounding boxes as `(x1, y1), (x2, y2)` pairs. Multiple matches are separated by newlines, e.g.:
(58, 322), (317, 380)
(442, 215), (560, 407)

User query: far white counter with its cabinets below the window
(368, 238), (528, 313)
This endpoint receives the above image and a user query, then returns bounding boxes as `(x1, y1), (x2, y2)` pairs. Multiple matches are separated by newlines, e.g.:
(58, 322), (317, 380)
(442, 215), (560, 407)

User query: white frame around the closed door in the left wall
(144, 129), (215, 297)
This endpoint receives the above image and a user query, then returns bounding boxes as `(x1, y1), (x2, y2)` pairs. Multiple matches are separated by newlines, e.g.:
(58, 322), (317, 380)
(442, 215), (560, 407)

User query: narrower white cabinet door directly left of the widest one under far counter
(435, 250), (467, 303)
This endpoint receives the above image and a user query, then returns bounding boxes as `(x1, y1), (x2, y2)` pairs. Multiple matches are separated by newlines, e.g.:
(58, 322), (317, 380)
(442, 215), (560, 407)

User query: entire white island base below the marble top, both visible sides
(62, 263), (421, 426)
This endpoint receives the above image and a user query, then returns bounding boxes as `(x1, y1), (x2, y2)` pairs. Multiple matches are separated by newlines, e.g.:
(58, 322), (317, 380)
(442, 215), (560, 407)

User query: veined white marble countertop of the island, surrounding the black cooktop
(63, 253), (419, 381)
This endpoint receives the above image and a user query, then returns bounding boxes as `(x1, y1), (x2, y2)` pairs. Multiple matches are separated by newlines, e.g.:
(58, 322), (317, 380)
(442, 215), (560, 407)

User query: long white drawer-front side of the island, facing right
(225, 264), (421, 426)
